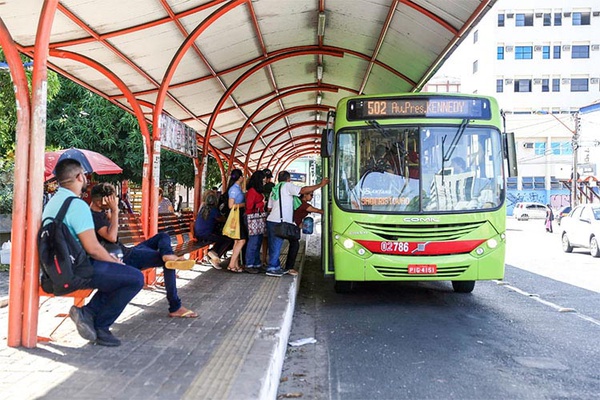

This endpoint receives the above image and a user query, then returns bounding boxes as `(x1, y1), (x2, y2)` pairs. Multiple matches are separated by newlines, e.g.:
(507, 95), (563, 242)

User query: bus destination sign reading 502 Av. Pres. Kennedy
(347, 97), (491, 121)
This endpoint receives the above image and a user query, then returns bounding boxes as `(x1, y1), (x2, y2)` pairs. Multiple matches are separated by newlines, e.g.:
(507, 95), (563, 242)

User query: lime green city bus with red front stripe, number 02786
(321, 93), (517, 293)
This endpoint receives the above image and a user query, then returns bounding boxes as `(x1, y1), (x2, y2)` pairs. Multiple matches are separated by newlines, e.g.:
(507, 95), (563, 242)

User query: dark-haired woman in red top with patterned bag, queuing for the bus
(244, 171), (267, 274)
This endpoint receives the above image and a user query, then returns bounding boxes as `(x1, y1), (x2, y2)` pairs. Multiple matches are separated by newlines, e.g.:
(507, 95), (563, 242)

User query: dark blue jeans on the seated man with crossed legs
(123, 232), (181, 312)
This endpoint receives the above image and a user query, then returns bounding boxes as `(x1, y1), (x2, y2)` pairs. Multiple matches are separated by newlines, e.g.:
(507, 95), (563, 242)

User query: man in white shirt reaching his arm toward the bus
(267, 171), (329, 276)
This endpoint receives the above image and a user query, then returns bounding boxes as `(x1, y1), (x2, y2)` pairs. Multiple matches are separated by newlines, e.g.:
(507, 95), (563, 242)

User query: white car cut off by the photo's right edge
(560, 204), (600, 257)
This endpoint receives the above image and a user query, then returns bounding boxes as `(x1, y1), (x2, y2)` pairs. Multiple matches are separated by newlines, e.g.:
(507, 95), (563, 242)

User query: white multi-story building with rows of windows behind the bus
(424, 0), (600, 207)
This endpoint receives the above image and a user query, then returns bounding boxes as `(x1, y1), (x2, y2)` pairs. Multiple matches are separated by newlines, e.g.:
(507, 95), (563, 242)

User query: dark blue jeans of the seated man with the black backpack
(84, 260), (144, 329)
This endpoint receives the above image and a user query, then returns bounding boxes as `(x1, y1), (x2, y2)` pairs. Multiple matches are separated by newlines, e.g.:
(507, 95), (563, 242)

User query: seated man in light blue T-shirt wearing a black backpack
(42, 159), (144, 346)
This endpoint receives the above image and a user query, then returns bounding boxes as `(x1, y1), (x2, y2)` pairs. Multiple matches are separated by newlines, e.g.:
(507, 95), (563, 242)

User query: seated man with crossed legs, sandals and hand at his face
(90, 183), (198, 318)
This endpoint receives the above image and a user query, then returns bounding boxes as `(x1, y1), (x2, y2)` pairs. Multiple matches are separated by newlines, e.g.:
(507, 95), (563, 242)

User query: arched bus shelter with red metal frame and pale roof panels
(0, 0), (495, 347)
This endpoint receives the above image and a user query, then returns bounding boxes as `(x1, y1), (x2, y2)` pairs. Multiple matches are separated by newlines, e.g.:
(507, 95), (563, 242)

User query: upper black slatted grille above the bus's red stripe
(357, 221), (485, 241)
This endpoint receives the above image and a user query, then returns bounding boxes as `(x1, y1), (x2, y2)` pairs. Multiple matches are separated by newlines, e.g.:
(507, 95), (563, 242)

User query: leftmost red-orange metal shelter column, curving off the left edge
(0, 18), (31, 347)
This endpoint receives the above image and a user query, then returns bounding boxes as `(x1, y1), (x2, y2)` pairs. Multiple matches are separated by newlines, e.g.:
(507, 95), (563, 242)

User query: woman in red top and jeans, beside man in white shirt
(244, 171), (266, 274)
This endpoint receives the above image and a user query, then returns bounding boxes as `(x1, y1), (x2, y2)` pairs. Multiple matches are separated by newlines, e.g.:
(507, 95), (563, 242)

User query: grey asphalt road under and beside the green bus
(279, 218), (600, 399)
